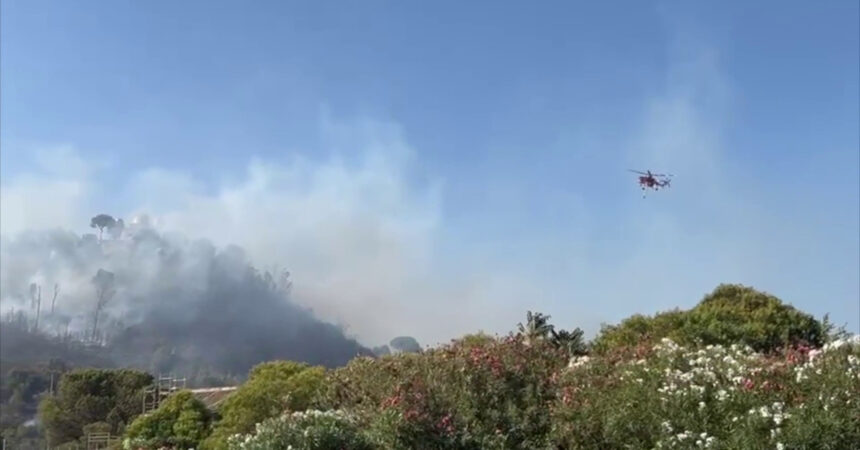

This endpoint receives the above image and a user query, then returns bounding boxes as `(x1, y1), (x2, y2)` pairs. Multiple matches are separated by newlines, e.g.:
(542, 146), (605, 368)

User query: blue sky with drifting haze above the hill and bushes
(0, 0), (860, 340)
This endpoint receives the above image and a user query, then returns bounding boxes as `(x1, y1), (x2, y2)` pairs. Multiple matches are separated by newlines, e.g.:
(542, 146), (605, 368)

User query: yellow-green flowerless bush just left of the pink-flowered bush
(203, 361), (325, 449)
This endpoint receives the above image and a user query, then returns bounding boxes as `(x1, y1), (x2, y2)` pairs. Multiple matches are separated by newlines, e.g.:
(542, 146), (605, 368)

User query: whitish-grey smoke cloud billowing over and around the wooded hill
(0, 118), (467, 372)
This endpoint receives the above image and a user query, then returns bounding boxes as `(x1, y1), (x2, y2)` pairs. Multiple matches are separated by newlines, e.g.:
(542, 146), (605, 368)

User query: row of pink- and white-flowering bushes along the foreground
(240, 328), (860, 449)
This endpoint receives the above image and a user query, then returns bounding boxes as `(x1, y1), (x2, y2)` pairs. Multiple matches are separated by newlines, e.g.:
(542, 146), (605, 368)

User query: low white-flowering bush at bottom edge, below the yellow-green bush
(228, 410), (373, 450)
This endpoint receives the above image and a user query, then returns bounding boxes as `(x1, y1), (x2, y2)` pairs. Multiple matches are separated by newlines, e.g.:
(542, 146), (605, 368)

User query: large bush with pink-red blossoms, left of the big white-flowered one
(325, 336), (567, 449)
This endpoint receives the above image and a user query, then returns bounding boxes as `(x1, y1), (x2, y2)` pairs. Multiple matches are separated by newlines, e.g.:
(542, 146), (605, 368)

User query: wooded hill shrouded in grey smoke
(0, 215), (369, 374)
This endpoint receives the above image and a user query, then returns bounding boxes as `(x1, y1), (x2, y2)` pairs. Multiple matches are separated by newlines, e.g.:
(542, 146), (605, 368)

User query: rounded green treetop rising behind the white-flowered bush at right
(593, 284), (828, 352)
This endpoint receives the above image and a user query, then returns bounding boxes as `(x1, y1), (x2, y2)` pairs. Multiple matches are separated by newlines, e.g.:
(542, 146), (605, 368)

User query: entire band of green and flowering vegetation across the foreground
(4, 285), (860, 450)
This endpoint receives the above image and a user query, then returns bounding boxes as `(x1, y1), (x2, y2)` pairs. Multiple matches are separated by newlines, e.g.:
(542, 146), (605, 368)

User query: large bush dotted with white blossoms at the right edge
(552, 336), (860, 449)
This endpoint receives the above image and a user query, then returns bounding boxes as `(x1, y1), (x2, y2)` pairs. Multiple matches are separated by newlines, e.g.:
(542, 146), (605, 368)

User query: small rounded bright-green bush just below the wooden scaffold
(123, 391), (213, 450)
